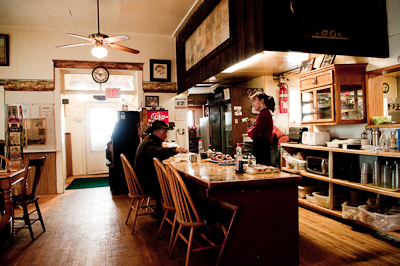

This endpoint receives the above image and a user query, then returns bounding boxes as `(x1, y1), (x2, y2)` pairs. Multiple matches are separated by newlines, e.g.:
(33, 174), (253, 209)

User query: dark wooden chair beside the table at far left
(13, 155), (47, 241)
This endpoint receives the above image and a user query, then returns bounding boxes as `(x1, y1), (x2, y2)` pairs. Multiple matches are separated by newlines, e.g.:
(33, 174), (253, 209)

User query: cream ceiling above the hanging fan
(0, 0), (202, 36)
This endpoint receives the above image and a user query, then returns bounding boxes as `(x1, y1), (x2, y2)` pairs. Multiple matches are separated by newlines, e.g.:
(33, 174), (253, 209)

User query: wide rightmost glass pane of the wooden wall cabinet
(340, 84), (366, 123)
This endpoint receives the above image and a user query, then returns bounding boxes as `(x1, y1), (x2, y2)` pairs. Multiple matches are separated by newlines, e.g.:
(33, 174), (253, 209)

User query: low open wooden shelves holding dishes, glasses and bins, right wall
(281, 143), (400, 240)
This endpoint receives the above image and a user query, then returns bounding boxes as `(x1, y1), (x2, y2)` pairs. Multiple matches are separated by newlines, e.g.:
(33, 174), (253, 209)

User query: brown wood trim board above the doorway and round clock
(53, 60), (144, 70)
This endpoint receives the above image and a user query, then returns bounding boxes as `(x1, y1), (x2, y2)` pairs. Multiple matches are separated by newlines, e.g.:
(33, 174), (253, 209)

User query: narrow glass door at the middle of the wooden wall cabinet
(315, 85), (334, 122)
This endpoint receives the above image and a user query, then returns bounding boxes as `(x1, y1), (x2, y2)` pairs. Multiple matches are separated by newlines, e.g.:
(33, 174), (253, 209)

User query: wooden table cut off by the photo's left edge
(0, 168), (25, 240)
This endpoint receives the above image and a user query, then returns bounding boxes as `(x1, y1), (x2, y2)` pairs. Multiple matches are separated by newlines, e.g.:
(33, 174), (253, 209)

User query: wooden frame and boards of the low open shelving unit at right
(281, 143), (400, 238)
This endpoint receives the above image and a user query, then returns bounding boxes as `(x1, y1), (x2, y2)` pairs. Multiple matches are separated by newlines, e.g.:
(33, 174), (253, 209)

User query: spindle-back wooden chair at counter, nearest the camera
(165, 162), (222, 266)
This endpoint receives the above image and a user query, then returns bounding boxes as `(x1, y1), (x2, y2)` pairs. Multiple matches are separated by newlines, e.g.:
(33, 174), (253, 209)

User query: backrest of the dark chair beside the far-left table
(19, 155), (47, 201)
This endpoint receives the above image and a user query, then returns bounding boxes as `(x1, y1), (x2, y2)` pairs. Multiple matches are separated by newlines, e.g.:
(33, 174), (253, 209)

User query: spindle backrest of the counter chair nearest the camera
(165, 162), (201, 223)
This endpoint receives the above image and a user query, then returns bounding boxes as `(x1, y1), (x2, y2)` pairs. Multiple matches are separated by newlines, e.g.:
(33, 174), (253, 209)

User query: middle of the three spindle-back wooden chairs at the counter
(153, 158), (176, 249)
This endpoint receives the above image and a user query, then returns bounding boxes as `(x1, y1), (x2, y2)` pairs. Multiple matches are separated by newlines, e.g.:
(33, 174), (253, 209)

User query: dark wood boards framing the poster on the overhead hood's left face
(176, 0), (263, 93)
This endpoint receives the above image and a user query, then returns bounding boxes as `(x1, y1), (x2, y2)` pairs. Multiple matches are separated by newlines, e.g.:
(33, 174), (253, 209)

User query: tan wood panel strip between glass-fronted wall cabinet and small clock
(366, 74), (383, 125)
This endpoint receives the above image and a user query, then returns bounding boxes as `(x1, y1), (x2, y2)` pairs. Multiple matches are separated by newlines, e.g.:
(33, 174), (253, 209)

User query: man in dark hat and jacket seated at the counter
(134, 121), (188, 210)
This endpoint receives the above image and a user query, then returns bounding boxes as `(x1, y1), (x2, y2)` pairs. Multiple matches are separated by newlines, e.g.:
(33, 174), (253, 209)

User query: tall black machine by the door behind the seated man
(106, 111), (140, 195)
